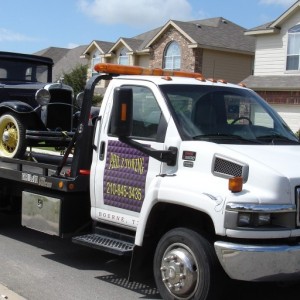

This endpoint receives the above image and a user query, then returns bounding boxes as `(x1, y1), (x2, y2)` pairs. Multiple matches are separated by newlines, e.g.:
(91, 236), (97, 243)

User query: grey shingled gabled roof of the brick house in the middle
(82, 17), (255, 57)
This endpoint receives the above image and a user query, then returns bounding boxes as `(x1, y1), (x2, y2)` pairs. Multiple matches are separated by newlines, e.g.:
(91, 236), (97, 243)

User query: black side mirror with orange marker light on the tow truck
(110, 88), (133, 137)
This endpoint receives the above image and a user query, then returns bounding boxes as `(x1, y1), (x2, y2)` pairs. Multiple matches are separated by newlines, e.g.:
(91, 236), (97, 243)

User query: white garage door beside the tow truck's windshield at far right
(272, 104), (300, 132)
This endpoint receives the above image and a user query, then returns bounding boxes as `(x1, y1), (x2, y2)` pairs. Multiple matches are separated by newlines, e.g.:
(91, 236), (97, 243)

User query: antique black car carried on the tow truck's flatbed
(0, 51), (74, 158)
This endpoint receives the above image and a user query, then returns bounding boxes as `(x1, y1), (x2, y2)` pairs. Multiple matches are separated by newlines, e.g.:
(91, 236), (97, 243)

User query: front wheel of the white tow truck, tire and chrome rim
(153, 228), (219, 300)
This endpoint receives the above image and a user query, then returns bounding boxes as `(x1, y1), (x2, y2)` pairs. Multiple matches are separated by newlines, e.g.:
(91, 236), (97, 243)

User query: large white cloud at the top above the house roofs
(78, 0), (193, 27)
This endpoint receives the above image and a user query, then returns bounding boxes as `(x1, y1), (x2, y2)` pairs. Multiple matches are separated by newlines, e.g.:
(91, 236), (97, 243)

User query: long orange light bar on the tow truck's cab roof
(94, 63), (203, 78)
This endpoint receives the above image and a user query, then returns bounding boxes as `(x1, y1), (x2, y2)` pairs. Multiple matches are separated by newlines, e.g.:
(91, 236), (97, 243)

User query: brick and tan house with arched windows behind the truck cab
(81, 17), (255, 91)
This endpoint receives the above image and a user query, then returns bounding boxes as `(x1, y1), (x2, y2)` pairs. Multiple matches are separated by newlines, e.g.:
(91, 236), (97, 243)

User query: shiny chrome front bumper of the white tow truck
(214, 242), (300, 281)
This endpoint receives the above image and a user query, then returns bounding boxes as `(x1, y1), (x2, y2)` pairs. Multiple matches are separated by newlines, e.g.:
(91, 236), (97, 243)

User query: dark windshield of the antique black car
(0, 59), (51, 83)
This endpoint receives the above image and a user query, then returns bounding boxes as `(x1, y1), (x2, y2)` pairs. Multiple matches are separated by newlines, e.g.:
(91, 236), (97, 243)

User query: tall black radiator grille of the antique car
(47, 89), (73, 131)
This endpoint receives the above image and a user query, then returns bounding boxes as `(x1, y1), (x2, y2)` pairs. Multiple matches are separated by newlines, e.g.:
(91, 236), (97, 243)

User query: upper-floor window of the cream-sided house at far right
(286, 25), (300, 71)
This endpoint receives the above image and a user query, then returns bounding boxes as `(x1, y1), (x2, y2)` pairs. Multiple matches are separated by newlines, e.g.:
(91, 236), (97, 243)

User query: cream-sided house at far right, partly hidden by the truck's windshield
(243, 1), (300, 132)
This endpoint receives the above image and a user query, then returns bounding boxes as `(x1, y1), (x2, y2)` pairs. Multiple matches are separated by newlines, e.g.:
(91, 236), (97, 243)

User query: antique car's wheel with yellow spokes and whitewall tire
(0, 112), (26, 158)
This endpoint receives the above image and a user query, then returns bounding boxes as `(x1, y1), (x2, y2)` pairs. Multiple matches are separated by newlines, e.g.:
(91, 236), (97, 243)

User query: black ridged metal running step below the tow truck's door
(72, 233), (134, 256)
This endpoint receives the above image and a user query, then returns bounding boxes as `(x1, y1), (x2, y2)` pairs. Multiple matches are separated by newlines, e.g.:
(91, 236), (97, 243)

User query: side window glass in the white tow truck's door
(109, 86), (163, 141)
